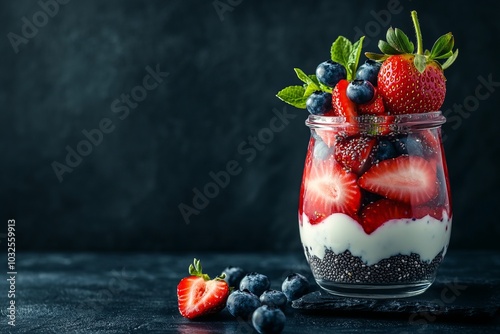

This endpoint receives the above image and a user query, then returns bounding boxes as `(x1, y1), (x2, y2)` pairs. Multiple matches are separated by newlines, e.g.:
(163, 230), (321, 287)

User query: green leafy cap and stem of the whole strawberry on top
(365, 11), (458, 73)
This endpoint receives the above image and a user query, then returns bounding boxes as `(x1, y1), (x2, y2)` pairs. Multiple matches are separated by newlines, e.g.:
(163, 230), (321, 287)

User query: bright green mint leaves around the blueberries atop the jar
(276, 36), (365, 109)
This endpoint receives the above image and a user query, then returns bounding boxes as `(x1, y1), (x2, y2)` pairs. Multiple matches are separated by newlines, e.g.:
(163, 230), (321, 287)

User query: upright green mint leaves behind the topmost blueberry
(330, 36), (365, 81)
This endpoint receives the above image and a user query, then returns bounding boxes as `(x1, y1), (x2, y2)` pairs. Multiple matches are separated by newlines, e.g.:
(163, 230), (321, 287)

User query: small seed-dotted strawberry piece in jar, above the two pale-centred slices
(335, 135), (377, 175)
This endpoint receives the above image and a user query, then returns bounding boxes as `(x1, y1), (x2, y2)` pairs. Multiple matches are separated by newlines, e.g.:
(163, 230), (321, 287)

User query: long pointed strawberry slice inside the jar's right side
(358, 156), (438, 205)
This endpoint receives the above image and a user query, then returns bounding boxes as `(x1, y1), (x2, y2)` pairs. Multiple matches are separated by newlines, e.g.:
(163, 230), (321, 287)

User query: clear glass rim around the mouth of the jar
(305, 111), (446, 128)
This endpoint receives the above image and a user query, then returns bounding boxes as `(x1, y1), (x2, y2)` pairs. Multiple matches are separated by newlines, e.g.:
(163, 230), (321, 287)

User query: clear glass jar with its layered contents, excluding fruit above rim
(299, 111), (452, 298)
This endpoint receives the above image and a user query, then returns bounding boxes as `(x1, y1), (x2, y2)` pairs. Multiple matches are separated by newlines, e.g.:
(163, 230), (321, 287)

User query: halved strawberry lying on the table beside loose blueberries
(177, 259), (229, 319)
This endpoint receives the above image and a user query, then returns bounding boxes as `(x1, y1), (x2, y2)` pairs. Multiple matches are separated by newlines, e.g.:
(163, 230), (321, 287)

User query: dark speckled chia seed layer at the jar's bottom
(306, 248), (443, 284)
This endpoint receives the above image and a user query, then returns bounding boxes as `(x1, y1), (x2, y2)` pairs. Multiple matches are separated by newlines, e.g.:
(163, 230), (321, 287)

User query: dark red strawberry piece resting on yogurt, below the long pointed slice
(361, 198), (412, 234)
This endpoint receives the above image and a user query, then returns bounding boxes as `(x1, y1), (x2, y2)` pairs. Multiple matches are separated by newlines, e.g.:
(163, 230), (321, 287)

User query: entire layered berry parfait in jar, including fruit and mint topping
(278, 11), (458, 298)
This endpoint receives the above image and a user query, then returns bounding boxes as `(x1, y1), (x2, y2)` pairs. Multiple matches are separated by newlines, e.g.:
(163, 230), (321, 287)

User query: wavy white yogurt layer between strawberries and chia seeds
(300, 212), (451, 265)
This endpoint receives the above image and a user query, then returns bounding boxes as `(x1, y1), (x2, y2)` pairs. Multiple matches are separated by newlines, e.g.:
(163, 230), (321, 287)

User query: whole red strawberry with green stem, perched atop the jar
(366, 11), (458, 114)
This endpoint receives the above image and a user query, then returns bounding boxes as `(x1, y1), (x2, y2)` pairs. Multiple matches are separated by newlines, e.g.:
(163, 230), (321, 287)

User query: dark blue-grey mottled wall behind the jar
(0, 0), (500, 251)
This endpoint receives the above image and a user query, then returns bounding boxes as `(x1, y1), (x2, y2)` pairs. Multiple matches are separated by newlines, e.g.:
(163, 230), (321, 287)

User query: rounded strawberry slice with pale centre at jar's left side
(302, 159), (361, 224)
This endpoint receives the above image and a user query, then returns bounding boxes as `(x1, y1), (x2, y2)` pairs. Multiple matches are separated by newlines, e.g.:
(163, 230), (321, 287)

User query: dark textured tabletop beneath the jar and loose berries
(0, 251), (500, 334)
